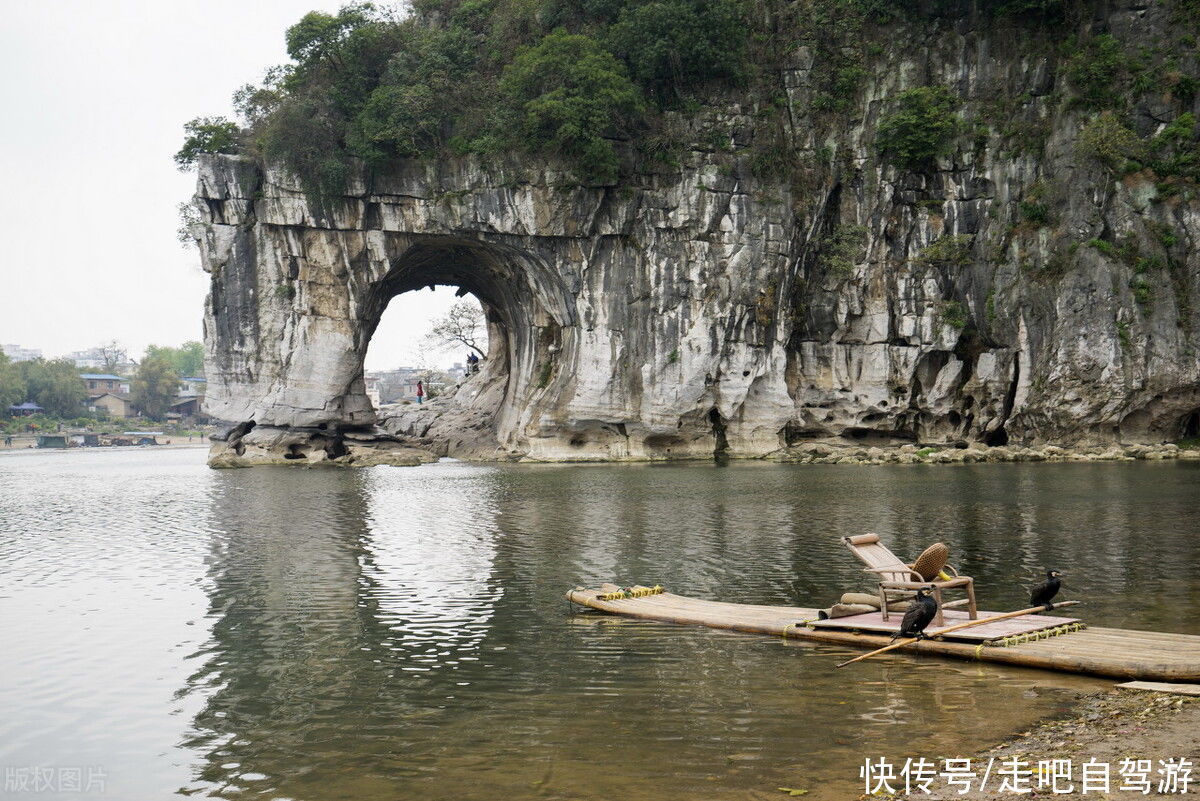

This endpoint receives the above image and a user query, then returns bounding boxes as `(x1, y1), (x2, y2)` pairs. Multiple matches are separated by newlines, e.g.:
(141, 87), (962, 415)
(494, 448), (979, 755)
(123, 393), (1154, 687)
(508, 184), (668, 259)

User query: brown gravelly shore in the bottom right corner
(892, 687), (1200, 801)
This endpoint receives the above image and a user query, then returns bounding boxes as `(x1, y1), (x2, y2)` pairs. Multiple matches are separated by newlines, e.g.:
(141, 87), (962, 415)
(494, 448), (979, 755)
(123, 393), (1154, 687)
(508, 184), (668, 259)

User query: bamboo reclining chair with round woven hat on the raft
(841, 534), (979, 626)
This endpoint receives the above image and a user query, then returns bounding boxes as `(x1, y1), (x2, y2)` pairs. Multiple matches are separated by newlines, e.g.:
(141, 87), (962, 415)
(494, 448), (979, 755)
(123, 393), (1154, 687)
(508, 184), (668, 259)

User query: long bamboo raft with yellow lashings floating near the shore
(566, 584), (1200, 681)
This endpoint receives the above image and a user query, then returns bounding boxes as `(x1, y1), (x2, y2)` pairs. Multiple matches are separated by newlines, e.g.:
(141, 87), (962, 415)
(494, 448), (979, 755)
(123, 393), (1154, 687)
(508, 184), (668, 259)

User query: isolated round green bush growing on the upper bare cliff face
(875, 86), (960, 170)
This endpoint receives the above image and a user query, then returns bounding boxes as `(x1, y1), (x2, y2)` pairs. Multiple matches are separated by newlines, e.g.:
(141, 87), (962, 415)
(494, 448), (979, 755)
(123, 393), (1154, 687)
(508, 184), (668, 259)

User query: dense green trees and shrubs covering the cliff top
(176, 0), (1200, 192)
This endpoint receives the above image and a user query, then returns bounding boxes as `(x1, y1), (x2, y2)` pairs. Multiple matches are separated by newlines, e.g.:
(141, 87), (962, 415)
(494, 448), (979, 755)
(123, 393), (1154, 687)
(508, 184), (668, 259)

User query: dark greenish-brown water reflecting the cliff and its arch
(164, 463), (1198, 801)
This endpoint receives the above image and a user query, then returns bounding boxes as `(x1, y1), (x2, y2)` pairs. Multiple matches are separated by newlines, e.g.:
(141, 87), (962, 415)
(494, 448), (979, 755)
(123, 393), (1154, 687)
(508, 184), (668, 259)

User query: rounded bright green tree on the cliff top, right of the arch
(500, 29), (642, 183)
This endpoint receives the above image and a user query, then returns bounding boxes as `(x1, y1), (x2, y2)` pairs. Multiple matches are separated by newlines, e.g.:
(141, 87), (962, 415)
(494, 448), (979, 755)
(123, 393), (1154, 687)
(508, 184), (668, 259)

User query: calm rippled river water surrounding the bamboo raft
(0, 450), (1200, 801)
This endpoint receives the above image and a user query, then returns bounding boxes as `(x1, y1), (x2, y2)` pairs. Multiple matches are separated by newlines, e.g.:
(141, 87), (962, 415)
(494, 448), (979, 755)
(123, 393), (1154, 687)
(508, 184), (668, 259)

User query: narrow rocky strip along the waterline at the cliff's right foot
(768, 441), (1200, 464)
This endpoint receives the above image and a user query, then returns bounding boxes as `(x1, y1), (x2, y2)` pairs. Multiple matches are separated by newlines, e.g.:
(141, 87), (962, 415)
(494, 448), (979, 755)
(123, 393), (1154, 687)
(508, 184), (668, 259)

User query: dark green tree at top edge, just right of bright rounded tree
(607, 0), (748, 103)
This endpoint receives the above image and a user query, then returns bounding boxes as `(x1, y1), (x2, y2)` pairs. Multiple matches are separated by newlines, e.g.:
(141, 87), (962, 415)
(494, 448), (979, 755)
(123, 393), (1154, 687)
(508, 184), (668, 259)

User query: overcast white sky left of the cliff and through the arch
(0, 0), (458, 369)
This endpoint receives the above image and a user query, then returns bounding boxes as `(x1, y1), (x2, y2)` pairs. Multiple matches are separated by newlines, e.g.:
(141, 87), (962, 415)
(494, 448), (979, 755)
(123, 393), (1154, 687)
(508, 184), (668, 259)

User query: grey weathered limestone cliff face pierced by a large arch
(196, 5), (1200, 464)
